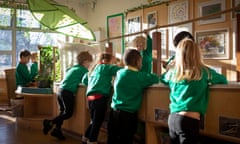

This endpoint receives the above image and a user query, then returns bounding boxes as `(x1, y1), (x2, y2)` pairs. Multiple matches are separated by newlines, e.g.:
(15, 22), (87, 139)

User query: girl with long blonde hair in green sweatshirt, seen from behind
(160, 38), (227, 144)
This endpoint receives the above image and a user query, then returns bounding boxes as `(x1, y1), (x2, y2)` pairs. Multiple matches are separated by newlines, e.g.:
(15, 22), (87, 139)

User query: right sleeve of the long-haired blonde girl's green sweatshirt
(208, 68), (228, 84)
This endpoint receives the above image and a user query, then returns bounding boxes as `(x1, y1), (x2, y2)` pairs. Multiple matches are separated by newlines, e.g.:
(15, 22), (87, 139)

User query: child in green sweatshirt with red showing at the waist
(82, 53), (121, 144)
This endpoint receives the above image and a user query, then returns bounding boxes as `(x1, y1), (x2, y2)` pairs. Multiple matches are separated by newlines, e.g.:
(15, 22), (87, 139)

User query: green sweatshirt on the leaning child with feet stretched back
(60, 64), (88, 94)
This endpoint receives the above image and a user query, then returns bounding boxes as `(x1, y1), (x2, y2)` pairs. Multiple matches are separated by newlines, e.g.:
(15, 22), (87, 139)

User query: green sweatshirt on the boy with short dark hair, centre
(111, 68), (159, 113)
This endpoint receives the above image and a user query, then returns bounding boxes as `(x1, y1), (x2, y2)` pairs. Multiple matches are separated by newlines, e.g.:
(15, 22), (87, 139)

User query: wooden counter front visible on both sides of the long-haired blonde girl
(143, 84), (240, 144)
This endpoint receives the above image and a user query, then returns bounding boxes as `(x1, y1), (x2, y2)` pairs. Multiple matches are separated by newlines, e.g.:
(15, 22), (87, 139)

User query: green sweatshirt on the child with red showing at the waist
(83, 64), (121, 97)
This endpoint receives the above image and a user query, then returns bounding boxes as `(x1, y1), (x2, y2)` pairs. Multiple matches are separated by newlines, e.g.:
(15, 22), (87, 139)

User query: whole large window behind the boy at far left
(0, 5), (66, 74)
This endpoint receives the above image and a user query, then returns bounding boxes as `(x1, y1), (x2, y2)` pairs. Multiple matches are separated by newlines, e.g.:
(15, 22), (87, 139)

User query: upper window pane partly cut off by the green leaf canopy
(17, 9), (40, 28)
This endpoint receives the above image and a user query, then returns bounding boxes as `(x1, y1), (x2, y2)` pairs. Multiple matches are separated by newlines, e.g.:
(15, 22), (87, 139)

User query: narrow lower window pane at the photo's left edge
(0, 30), (12, 51)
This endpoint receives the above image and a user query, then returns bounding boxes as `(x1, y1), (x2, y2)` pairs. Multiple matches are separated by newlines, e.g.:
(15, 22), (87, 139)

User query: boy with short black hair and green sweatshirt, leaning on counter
(107, 49), (159, 144)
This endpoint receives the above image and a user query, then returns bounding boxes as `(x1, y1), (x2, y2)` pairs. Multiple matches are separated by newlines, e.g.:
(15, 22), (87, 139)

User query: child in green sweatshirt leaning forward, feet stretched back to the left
(43, 51), (92, 140)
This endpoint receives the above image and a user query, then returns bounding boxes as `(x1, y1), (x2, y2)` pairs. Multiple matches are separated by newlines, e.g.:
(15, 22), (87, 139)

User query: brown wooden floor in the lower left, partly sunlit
(0, 104), (81, 144)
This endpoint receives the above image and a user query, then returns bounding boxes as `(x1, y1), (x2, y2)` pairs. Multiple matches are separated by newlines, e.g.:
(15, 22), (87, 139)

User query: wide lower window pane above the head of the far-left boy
(16, 31), (65, 63)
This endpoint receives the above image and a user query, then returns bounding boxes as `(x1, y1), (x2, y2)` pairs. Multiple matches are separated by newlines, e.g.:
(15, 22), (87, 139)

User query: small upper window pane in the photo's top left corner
(0, 8), (11, 26)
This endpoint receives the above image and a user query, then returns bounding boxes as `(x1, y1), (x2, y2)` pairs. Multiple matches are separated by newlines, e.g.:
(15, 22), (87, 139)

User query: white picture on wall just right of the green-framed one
(127, 16), (142, 42)
